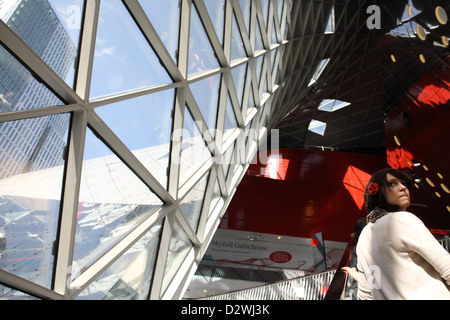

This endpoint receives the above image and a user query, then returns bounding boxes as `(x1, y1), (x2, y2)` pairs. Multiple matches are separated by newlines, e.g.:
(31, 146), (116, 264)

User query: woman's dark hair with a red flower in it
(364, 168), (412, 213)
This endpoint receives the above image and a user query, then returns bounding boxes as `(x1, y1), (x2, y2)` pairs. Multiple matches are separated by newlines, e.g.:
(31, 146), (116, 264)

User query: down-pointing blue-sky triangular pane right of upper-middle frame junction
(190, 74), (221, 137)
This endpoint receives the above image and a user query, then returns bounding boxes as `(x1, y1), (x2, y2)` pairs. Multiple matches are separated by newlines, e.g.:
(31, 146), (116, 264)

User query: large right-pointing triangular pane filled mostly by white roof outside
(73, 129), (163, 269)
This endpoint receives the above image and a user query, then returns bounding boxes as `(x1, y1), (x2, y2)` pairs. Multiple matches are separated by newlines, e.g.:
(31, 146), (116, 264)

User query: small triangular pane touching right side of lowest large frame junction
(180, 174), (209, 232)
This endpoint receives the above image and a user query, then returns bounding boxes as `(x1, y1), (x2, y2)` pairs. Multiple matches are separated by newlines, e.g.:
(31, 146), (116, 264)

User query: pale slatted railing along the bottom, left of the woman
(201, 269), (336, 300)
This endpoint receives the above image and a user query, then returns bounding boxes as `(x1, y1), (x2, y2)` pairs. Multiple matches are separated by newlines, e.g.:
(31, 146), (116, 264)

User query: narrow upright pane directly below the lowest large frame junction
(162, 221), (193, 291)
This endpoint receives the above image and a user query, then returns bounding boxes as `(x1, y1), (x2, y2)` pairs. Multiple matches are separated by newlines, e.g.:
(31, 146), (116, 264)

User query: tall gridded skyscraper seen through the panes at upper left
(0, 0), (76, 179)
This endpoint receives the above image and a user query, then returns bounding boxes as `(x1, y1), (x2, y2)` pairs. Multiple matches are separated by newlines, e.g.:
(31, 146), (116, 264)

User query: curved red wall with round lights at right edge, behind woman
(386, 58), (450, 229)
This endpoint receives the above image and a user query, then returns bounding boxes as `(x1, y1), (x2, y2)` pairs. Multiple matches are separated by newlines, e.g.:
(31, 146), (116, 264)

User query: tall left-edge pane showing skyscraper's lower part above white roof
(0, 114), (70, 288)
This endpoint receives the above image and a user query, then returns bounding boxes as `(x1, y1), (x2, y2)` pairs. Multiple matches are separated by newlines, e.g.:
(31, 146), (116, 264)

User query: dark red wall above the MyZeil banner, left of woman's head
(220, 149), (387, 242)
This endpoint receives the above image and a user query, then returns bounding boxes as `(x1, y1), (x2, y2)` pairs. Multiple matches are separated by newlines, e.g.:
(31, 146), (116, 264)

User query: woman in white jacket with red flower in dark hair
(356, 169), (450, 300)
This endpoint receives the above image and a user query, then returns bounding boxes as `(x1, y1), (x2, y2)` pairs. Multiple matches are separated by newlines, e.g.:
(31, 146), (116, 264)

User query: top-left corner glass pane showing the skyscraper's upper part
(0, 0), (83, 86)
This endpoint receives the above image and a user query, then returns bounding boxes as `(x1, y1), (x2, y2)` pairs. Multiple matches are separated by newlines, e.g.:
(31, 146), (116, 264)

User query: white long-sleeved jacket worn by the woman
(356, 211), (450, 300)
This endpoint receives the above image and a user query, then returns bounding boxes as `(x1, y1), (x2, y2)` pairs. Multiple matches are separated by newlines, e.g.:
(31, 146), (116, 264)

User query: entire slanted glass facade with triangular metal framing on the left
(0, 0), (304, 300)
